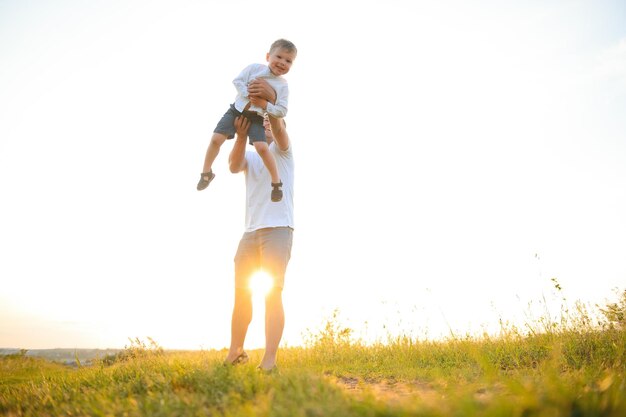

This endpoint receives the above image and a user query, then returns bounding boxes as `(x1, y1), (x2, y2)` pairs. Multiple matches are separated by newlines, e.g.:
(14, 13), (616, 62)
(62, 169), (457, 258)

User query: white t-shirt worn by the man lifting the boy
(245, 142), (294, 232)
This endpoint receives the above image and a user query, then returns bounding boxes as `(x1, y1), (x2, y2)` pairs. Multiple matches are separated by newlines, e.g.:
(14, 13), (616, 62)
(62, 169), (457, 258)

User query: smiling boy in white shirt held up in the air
(197, 39), (298, 202)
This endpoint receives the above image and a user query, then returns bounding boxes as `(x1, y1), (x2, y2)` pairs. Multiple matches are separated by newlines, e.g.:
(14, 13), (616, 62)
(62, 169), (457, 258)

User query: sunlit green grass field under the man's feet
(0, 292), (626, 417)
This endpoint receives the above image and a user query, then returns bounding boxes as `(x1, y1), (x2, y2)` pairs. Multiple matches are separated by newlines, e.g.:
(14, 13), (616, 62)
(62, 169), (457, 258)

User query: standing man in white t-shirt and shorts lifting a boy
(225, 80), (294, 372)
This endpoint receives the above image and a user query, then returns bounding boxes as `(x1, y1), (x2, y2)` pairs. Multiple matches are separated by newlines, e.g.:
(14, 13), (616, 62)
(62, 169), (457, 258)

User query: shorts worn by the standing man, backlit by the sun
(235, 227), (293, 288)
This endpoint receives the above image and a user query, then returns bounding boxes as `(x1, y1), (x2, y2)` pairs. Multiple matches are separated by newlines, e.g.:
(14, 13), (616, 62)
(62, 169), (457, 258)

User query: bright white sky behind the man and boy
(0, 0), (626, 349)
